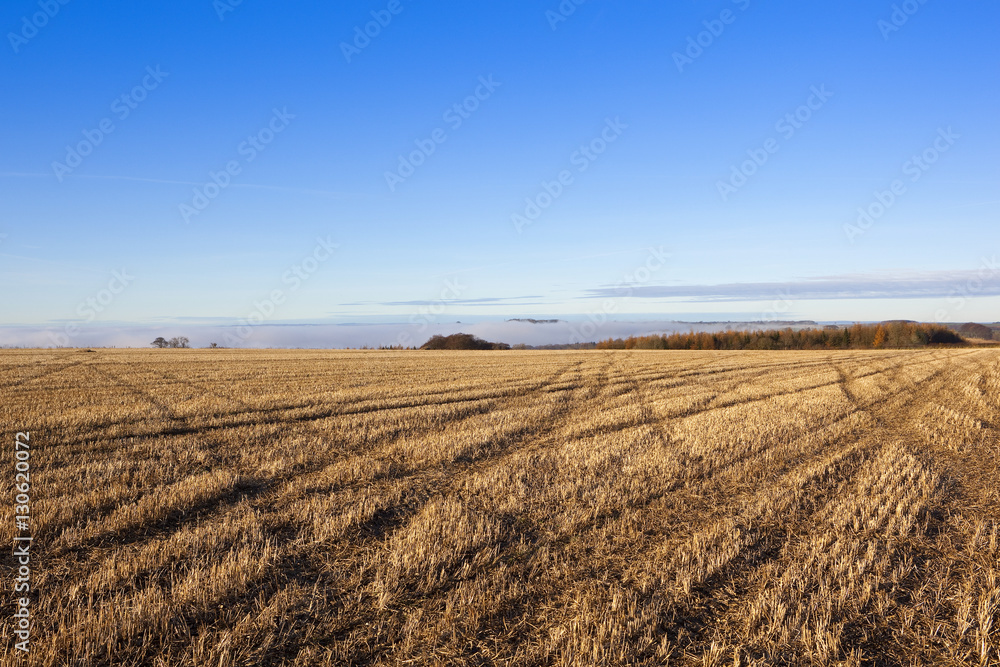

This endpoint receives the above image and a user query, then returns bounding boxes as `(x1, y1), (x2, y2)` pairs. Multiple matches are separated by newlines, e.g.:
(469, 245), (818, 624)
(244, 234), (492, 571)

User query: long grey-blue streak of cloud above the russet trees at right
(579, 271), (1000, 302)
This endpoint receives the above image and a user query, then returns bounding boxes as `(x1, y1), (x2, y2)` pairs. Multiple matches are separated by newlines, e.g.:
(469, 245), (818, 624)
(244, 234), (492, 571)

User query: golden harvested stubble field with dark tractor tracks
(0, 349), (1000, 666)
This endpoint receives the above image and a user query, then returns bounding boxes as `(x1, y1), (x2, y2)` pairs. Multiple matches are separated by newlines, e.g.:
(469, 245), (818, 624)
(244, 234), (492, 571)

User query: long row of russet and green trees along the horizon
(597, 321), (965, 350)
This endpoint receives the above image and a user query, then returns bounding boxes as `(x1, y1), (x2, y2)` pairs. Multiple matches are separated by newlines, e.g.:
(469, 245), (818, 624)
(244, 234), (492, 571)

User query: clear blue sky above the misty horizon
(0, 0), (1000, 344)
